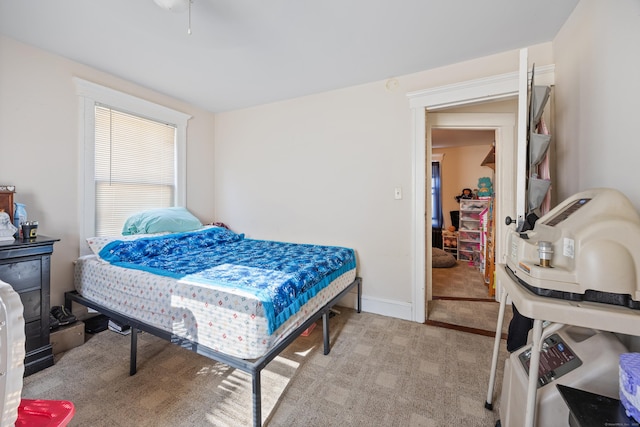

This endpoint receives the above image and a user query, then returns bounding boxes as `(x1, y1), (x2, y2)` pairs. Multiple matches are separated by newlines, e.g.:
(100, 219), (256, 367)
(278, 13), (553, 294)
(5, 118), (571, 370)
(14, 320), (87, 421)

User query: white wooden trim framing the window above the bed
(73, 77), (191, 255)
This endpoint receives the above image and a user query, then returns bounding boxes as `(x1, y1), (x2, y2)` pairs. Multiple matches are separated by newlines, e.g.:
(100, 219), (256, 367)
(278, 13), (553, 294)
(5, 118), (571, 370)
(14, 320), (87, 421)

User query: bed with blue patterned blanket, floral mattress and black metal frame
(65, 221), (362, 426)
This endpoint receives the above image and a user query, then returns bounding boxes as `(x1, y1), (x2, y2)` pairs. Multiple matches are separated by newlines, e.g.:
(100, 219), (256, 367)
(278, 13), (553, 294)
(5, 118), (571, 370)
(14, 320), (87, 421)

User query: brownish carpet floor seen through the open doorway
(427, 261), (512, 334)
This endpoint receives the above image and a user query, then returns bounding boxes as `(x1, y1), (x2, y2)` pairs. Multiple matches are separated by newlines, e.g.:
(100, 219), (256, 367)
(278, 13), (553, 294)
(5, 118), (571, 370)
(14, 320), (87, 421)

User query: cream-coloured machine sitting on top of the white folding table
(506, 188), (640, 309)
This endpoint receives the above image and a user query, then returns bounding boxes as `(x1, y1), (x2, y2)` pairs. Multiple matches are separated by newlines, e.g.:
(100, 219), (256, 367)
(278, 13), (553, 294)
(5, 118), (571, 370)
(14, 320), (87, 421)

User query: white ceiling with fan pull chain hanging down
(0, 0), (578, 112)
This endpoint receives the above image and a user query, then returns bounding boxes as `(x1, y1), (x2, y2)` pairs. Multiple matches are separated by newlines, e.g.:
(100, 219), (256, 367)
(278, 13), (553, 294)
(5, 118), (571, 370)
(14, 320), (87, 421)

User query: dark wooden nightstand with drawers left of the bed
(0, 236), (60, 376)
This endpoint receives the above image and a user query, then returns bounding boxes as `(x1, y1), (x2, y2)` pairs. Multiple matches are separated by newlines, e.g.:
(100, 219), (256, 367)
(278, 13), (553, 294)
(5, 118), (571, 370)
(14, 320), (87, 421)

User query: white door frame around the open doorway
(407, 65), (554, 323)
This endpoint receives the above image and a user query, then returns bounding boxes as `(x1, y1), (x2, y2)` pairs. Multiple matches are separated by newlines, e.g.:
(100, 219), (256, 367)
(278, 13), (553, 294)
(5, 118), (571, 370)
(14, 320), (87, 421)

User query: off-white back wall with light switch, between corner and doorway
(215, 43), (551, 318)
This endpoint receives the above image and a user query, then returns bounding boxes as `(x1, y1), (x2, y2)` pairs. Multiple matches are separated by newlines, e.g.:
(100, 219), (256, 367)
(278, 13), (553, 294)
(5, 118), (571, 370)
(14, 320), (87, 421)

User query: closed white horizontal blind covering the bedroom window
(95, 104), (176, 236)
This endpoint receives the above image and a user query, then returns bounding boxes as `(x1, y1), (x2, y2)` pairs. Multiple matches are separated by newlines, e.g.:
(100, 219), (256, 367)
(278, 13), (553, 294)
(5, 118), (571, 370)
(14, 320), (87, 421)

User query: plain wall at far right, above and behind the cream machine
(553, 0), (640, 210)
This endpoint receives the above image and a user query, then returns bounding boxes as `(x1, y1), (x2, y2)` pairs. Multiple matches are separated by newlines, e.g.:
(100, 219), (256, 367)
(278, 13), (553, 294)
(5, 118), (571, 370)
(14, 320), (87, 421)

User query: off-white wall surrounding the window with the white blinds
(0, 36), (214, 305)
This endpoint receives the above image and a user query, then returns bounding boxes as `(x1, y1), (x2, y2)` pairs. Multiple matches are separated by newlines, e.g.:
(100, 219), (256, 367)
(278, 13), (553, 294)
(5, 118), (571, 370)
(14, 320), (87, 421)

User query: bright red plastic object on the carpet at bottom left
(16, 399), (76, 427)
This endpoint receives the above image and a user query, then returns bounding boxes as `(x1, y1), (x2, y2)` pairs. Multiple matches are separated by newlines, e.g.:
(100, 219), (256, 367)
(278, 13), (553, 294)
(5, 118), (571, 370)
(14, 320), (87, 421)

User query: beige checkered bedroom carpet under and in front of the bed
(23, 308), (506, 427)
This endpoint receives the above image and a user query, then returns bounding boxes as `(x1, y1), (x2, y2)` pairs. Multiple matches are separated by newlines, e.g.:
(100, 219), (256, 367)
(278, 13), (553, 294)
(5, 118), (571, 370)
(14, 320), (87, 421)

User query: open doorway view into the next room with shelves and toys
(425, 119), (517, 336)
